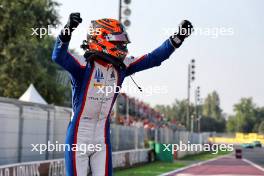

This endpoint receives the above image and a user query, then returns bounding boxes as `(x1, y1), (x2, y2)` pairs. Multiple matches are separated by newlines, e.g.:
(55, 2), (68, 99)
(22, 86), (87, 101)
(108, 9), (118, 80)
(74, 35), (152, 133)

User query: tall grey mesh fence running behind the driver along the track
(0, 97), (210, 164)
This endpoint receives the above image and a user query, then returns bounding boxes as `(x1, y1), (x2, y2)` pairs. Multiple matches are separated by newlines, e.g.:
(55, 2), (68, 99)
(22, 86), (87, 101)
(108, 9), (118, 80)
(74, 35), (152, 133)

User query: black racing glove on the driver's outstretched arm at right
(170, 20), (194, 48)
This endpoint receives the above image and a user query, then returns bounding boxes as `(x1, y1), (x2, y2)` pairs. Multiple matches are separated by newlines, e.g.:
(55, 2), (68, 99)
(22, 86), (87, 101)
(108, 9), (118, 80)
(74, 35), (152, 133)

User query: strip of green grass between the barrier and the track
(114, 152), (230, 176)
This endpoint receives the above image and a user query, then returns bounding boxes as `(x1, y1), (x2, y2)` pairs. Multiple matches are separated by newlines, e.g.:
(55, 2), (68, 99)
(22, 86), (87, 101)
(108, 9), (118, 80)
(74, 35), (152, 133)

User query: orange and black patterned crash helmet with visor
(86, 18), (130, 61)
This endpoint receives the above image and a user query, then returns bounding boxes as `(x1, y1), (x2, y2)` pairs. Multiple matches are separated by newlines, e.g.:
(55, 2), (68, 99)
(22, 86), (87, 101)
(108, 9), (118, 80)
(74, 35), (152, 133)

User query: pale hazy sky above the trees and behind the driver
(51, 0), (264, 114)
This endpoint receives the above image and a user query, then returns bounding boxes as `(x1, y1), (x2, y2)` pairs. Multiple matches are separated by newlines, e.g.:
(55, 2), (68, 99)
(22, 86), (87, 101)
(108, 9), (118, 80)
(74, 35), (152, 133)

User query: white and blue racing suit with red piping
(52, 37), (175, 176)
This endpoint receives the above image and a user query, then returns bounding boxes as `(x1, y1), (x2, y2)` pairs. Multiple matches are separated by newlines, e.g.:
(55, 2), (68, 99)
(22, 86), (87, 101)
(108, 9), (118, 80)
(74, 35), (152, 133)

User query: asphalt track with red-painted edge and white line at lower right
(162, 148), (264, 176)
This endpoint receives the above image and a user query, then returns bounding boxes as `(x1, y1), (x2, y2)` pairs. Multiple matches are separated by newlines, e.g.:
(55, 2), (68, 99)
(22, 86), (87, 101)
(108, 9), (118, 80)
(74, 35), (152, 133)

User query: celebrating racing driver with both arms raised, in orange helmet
(52, 13), (193, 176)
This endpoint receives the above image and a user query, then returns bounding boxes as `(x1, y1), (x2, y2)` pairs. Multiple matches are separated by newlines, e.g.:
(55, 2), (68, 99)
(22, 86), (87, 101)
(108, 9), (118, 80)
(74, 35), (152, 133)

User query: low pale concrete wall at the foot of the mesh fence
(0, 149), (149, 176)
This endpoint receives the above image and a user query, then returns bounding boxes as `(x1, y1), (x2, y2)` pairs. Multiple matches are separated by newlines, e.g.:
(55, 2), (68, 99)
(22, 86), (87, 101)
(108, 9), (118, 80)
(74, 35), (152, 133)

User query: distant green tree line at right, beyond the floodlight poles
(155, 91), (264, 134)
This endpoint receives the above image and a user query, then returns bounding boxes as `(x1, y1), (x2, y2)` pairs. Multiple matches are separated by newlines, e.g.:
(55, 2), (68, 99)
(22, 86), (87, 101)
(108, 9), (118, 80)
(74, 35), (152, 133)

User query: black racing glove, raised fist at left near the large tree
(59, 13), (82, 42)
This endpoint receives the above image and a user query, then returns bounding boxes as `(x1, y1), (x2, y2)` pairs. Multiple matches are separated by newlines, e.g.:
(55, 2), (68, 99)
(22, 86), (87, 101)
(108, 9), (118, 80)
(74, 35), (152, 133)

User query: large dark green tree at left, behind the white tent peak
(0, 0), (68, 104)
